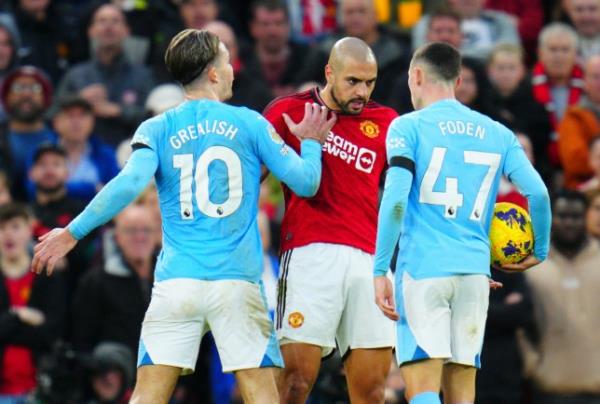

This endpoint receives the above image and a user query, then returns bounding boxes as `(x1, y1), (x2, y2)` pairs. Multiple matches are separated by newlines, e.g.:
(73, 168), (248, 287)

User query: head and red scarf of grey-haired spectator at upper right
(532, 23), (583, 165)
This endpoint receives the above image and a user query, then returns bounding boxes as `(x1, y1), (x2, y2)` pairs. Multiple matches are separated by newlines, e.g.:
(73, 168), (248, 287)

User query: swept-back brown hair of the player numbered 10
(165, 29), (220, 86)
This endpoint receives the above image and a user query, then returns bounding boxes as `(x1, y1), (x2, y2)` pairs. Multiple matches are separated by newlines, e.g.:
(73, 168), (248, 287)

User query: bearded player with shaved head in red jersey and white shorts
(264, 38), (397, 403)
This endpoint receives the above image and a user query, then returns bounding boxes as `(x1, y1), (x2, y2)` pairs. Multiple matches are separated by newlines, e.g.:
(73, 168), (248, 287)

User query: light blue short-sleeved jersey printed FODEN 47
(387, 99), (530, 279)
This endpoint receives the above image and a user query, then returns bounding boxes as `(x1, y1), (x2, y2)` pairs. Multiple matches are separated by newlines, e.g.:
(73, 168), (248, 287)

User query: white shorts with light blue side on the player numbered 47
(396, 272), (490, 368)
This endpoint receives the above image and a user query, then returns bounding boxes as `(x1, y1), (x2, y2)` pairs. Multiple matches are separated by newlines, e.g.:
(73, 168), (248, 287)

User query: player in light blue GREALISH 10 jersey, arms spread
(32, 30), (336, 403)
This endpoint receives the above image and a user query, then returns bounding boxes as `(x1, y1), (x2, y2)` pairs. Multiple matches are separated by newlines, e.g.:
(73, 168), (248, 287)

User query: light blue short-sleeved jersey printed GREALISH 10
(131, 100), (321, 282)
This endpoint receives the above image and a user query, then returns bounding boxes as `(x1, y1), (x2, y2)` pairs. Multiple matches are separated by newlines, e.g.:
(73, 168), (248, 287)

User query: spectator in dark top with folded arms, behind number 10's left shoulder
(57, 4), (154, 146)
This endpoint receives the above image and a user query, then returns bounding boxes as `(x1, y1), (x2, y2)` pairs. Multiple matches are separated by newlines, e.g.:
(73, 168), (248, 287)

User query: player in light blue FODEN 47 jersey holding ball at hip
(374, 43), (551, 404)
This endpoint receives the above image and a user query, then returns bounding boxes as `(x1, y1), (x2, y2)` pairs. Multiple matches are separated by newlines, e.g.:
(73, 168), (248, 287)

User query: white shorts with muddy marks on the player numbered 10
(138, 278), (283, 374)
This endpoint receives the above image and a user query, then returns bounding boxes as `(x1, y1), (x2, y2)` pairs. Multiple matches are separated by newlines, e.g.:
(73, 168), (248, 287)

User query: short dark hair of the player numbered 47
(412, 42), (461, 81)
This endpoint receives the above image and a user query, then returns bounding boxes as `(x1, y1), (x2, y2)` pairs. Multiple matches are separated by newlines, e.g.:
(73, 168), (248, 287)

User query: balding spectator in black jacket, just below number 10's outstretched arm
(73, 205), (160, 352)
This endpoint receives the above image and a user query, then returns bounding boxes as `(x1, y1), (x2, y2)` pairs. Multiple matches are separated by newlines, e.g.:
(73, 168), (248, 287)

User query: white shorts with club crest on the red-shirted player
(276, 243), (396, 357)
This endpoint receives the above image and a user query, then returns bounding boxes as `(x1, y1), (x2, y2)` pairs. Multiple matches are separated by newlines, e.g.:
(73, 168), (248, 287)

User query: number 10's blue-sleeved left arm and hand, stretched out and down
(32, 147), (158, 275)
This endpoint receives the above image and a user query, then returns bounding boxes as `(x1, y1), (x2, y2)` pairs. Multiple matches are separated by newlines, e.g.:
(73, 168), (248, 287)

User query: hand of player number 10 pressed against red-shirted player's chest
(282, 102), (337, 144)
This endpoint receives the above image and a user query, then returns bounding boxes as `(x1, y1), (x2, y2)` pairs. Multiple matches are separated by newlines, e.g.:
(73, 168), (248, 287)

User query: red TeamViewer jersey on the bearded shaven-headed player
(264, 89), (398, 254)
